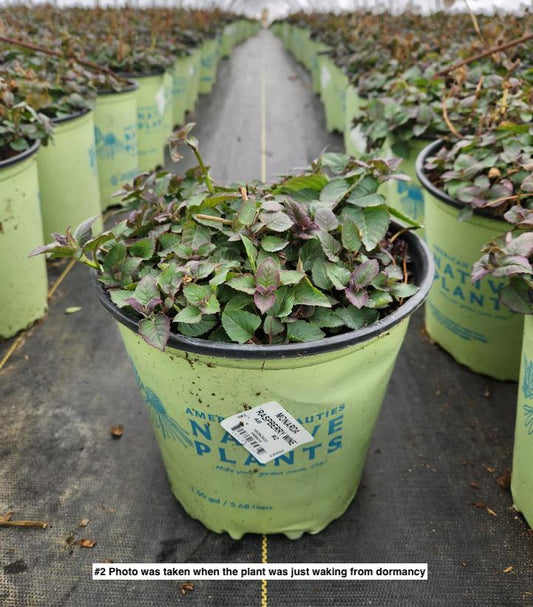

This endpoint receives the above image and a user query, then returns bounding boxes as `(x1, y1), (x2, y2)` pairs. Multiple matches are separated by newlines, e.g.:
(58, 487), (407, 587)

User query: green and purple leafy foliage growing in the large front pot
(34, 125), (418, 349)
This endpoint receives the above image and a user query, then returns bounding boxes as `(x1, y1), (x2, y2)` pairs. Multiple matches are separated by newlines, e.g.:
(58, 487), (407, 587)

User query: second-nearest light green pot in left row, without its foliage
(37, 110), (102, 242)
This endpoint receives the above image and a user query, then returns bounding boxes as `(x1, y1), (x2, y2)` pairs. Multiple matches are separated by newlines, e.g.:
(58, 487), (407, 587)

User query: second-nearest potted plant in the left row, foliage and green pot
(0, 47), (100, 242)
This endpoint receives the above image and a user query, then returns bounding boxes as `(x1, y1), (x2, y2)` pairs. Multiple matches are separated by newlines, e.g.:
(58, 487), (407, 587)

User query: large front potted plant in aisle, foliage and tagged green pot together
(30, 126), (433, 538)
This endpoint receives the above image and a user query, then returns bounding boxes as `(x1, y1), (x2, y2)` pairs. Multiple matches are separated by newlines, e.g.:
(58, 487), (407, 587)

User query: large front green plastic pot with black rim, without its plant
(97, 234), (433, 539)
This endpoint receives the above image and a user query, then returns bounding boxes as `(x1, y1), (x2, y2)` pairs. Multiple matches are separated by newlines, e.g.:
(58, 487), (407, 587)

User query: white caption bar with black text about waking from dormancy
(93, 563), (428, 580)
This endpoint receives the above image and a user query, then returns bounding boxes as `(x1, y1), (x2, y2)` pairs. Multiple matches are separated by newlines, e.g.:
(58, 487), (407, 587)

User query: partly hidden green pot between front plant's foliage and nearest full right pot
(386, 139), (430, 232)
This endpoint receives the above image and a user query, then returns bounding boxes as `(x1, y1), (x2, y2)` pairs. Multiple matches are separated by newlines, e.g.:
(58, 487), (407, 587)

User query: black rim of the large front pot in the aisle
(95, 224), (434, 360)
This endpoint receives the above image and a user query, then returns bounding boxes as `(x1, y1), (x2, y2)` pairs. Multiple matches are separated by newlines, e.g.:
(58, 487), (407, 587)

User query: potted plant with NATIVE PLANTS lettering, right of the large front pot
(417, 107), (533, 380)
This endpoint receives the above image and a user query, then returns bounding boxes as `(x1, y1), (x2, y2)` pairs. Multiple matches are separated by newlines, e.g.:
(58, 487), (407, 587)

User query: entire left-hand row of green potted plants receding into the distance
(0, 5), (256, 338)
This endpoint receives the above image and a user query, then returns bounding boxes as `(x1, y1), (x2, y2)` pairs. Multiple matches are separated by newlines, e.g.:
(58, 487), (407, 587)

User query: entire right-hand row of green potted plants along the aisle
(278, 13), (533, 524)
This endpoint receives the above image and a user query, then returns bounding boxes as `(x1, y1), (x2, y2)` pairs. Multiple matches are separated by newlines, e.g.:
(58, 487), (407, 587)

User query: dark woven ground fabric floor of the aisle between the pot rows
(0, 31), (533, 607)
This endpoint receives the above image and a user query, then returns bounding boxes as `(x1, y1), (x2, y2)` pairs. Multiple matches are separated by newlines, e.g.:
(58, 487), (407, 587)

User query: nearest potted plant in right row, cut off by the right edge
(472, 207), (533, 527)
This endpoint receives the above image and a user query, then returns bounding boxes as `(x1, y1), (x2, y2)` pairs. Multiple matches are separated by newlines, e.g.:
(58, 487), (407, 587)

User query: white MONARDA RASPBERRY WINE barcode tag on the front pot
(220, 401), (314, 464)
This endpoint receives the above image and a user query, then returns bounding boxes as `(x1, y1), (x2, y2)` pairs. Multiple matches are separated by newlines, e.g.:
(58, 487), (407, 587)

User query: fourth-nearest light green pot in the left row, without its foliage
(123, 69), (169, 172)
